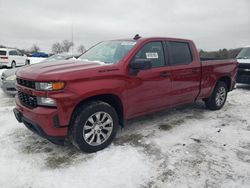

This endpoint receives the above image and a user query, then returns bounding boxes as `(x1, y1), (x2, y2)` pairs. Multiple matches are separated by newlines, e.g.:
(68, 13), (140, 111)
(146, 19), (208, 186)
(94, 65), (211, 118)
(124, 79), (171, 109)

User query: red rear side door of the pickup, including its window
(165, 41), (201, 106)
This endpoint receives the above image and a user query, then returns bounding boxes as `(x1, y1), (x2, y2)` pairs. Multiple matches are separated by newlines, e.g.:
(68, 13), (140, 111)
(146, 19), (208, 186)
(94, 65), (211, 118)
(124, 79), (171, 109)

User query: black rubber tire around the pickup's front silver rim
(69, 101), (119, 153)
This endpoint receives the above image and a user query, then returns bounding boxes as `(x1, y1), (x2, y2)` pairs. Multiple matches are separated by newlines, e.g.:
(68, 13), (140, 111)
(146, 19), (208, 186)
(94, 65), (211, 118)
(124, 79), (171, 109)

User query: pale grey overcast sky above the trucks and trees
(0, 0), (250, 51)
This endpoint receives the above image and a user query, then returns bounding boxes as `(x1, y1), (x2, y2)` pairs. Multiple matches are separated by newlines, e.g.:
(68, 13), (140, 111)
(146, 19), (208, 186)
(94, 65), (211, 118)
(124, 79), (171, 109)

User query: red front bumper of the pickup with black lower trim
(14, 96), (68, 145)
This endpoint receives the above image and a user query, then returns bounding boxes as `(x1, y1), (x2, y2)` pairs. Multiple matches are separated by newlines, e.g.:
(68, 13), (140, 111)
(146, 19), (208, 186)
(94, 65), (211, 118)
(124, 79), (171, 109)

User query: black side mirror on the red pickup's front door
(129, 59), (152, 75)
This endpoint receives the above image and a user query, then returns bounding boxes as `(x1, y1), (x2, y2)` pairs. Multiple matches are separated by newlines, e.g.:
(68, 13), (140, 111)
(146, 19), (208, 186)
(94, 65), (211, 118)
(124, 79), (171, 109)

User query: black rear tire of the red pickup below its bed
(204, 81), (228, 110)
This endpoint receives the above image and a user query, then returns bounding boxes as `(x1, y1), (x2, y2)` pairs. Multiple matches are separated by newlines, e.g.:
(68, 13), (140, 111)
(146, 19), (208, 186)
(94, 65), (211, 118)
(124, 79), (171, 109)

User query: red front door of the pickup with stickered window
(127, 41), (172, 118)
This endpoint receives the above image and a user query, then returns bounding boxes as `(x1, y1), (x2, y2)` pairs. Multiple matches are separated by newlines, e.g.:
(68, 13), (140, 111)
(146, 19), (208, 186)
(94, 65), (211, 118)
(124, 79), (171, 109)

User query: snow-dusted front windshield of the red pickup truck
(78, 40), (136, 64)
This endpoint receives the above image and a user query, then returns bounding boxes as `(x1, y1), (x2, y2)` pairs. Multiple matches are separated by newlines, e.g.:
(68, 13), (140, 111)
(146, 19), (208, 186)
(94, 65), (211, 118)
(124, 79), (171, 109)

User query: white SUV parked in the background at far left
(0, 48), (29, 68)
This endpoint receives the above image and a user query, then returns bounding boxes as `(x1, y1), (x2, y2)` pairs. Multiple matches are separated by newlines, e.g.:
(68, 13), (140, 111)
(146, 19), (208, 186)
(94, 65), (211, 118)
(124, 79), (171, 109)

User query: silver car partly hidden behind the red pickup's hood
(1, 54), (79, 96)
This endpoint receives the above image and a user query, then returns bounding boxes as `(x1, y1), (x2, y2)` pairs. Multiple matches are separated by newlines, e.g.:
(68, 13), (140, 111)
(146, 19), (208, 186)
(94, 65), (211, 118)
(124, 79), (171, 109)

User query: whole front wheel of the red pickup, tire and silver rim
(70, 101), (119, 153)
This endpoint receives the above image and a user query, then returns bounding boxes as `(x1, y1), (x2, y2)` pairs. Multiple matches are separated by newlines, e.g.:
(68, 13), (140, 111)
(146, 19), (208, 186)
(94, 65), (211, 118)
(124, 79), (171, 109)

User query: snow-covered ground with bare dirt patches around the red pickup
(0, 70), (250, 188)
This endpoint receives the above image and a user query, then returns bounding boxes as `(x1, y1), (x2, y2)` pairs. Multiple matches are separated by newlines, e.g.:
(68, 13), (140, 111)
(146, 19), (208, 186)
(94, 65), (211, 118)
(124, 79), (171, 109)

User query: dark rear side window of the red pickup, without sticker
(168, 42), (192, 65)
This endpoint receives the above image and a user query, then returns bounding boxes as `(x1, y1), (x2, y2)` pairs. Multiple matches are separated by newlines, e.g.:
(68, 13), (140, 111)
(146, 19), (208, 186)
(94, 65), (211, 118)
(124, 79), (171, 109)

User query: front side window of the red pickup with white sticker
(134, 42), (165, 67)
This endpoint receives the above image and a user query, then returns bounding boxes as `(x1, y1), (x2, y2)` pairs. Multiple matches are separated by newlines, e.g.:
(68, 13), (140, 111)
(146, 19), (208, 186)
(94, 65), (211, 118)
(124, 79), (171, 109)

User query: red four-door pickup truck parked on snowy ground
(14, 36), (238, 152)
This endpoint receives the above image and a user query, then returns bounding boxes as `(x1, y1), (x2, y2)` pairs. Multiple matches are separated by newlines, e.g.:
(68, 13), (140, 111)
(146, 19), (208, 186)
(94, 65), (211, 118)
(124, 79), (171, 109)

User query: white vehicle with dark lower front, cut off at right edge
(236, 46), (250, 84)
